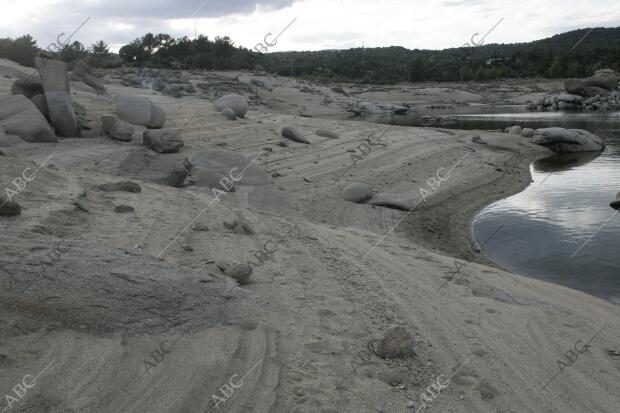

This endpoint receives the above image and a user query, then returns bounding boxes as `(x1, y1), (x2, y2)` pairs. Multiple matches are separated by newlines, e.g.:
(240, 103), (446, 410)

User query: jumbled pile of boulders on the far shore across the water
(527, 69), (620, 112)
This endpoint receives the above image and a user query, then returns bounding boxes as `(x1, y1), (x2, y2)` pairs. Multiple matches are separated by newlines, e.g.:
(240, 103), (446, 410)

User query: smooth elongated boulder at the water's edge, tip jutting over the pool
(532, 128), (605, 152)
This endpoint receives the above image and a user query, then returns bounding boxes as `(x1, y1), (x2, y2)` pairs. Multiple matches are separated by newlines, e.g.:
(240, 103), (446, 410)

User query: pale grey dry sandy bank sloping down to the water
(0, 61), (620, 413)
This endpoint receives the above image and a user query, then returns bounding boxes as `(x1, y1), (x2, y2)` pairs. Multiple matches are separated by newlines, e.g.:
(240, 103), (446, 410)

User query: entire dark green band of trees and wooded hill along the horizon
(0, 27), (620, 83)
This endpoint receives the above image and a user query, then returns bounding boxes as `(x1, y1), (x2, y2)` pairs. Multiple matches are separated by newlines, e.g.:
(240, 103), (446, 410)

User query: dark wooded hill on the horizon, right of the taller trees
(259, 27), (620, 83)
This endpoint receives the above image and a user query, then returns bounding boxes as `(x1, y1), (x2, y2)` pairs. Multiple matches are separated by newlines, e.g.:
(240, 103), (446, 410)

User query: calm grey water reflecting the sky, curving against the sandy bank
(464, 112), (620, 304)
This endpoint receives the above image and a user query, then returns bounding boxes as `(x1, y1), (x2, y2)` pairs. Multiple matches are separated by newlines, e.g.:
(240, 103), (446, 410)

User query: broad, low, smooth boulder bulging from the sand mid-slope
(189, 149), (271, 186)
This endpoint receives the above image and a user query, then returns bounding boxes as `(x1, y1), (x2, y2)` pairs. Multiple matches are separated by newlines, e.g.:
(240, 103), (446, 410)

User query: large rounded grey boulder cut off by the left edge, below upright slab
(0, 95), (58, 142)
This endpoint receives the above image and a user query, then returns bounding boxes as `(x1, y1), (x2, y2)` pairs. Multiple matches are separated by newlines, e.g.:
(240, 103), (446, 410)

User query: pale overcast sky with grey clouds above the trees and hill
(0, 0), (620, 51)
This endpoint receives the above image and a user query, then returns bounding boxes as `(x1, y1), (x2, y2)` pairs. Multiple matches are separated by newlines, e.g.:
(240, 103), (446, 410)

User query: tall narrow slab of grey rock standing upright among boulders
(35, 57), (80, 137)
